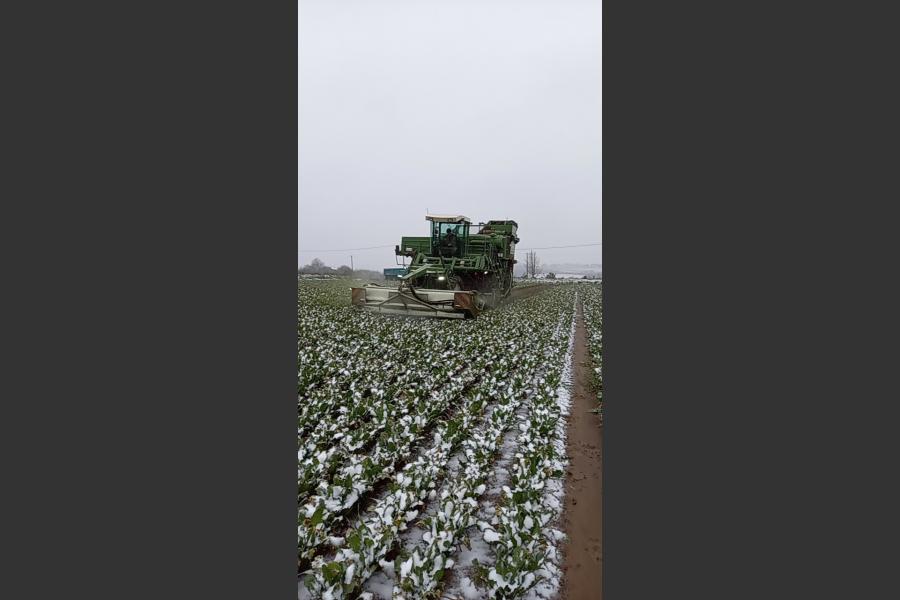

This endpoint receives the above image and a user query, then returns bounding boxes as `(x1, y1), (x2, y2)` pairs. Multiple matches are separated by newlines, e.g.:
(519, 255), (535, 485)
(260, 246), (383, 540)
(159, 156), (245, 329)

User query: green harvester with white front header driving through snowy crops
(351, 215), (519, 319)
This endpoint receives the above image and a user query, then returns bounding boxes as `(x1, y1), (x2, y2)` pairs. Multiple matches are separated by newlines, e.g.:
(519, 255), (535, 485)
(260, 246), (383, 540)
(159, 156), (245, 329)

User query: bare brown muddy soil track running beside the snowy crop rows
(559, 302), (603, 600)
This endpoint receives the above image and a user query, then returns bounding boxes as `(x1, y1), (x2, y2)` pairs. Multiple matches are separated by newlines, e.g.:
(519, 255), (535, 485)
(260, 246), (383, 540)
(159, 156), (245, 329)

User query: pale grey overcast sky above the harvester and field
(297, 0), (602, 270)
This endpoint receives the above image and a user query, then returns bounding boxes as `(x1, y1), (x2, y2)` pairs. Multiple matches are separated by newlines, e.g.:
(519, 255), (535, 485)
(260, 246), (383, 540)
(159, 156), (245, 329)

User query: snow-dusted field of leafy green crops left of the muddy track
(297, 280), (602, 600)
